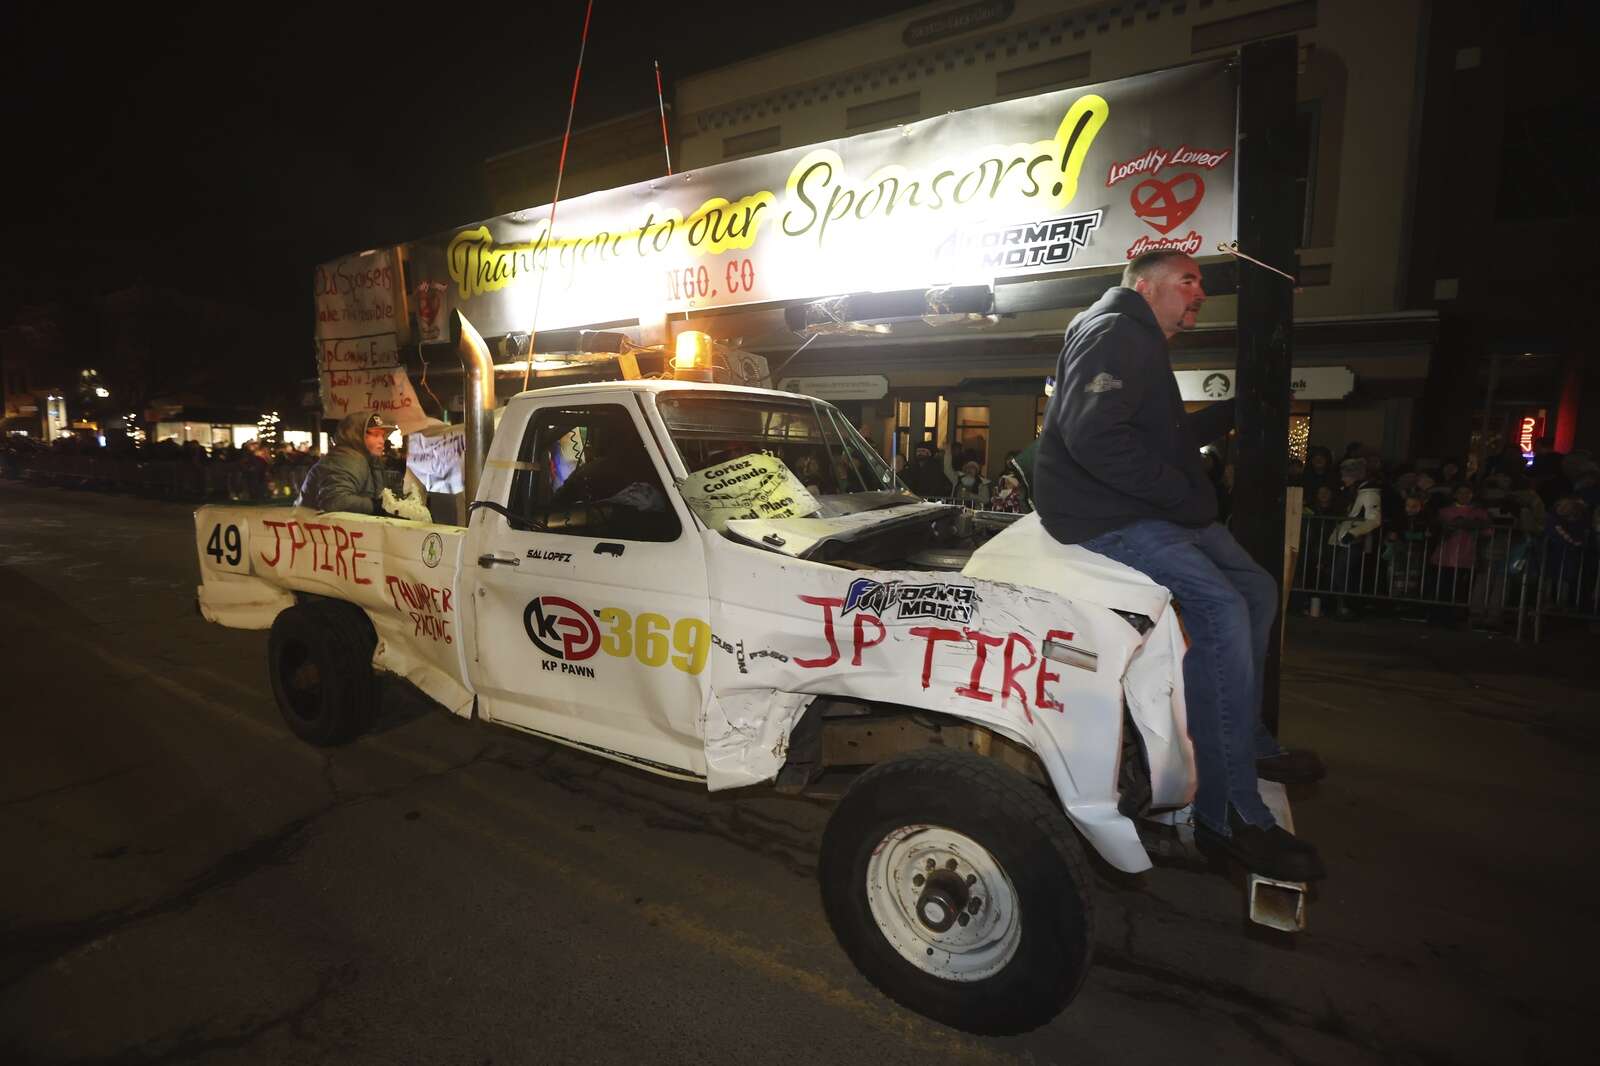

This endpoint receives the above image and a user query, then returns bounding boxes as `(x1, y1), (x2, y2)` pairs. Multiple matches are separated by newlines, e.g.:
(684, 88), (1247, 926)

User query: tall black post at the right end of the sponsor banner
(1232, 37), (1301, 733)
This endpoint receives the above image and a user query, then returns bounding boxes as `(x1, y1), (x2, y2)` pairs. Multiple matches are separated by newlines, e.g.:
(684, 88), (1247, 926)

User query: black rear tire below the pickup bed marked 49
(267, 600), (378, 746)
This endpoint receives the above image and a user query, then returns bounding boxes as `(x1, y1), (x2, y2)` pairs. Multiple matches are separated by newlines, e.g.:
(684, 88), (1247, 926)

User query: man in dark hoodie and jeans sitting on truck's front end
(1034, 250), (1323, 880)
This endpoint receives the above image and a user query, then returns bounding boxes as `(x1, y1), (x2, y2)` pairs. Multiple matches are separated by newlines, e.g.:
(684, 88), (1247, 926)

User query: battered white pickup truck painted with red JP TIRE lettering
(195, 361), (1302, 1032)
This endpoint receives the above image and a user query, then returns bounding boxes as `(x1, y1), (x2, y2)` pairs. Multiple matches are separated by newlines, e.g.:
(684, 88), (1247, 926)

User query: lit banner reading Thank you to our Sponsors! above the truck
(390, 61), (1235, 335)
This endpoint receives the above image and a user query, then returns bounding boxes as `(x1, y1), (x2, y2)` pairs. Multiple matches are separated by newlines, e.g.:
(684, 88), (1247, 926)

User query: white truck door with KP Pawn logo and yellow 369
(462, 395), (710, 775)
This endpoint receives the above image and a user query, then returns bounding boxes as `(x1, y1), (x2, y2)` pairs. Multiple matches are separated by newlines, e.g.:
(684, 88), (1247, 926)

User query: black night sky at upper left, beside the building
(0, 0), (917, 358)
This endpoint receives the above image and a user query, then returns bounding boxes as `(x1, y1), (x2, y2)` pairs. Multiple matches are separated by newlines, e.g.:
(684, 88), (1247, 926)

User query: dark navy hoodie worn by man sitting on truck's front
(1034, 285), (1234, 544)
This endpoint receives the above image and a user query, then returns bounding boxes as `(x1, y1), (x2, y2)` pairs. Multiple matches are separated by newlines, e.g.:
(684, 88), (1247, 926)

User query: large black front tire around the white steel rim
(818, 749), (1094, 1034)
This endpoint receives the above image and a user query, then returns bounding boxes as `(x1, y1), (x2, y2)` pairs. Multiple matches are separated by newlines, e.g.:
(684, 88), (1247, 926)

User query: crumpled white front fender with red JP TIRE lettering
(706, 535), (1170, 872)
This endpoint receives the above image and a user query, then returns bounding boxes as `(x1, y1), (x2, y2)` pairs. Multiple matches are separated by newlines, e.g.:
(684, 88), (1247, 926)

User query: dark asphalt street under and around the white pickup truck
(0, 482), (1600, 1066)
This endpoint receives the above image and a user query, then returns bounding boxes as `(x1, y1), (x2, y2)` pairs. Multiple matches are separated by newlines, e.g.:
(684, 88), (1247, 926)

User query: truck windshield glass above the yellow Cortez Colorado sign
(658, 392), (904, 498)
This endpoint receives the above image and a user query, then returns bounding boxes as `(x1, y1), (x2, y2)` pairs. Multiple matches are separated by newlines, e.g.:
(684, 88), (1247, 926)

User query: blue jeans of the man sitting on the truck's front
(1083, 519), (1283, 836)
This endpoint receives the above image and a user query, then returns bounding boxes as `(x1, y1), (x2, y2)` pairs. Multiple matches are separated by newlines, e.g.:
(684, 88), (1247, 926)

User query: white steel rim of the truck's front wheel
(866, 826), (1022, 981)
